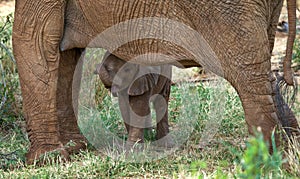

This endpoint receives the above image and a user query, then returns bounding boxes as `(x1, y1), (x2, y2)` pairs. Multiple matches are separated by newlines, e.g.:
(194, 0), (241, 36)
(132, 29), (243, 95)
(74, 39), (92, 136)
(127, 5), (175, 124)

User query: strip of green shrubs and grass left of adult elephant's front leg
(0, 15), (28, 169)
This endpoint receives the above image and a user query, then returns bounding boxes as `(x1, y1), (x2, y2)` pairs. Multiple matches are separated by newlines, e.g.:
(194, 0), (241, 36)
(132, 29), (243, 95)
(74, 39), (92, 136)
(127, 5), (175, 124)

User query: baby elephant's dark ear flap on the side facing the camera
(128, 73), (159, 96)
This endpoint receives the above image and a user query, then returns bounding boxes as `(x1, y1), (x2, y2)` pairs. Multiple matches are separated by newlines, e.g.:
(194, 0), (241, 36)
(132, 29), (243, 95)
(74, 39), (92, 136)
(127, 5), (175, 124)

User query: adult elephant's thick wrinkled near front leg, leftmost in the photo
(13, 0), (68, 163)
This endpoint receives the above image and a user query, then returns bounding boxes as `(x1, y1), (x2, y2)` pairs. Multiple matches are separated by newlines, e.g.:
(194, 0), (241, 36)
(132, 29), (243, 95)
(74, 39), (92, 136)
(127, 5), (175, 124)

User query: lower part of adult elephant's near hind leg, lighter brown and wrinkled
(231, 60), (280, 152)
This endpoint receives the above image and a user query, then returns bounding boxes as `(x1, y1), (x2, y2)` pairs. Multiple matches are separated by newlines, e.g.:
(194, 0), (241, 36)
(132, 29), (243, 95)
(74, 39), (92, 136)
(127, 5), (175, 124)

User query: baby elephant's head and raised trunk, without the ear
(95, 53), (138, 94)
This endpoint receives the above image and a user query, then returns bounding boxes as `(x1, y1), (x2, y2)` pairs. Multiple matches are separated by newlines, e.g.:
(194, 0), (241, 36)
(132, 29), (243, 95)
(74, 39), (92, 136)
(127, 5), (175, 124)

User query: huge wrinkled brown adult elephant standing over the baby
(13, 0), (299, 163)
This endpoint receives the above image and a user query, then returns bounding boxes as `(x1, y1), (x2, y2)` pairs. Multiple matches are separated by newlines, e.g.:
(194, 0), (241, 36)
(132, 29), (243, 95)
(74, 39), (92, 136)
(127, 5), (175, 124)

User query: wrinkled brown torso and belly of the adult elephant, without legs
(61, 0), (269, 73)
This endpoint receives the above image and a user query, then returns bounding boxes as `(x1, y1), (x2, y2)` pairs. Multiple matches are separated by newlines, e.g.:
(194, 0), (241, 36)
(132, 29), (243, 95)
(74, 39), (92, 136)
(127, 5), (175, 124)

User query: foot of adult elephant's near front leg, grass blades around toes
(26, 144), (70, 166)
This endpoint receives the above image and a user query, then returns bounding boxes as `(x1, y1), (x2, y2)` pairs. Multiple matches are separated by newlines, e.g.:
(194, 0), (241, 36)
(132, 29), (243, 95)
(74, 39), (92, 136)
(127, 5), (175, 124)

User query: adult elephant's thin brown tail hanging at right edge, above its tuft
(283, 0), (296, 86)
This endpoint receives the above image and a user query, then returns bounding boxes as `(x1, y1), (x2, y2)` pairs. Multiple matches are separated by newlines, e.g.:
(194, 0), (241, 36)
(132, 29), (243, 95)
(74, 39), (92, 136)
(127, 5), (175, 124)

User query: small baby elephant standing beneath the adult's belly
(95, 53), (173, 147)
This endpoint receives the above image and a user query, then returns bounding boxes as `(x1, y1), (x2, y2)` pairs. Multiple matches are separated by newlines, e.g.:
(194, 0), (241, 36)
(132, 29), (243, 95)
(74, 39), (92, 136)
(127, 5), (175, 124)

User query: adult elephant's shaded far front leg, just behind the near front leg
(56, 49), (87, 153)
